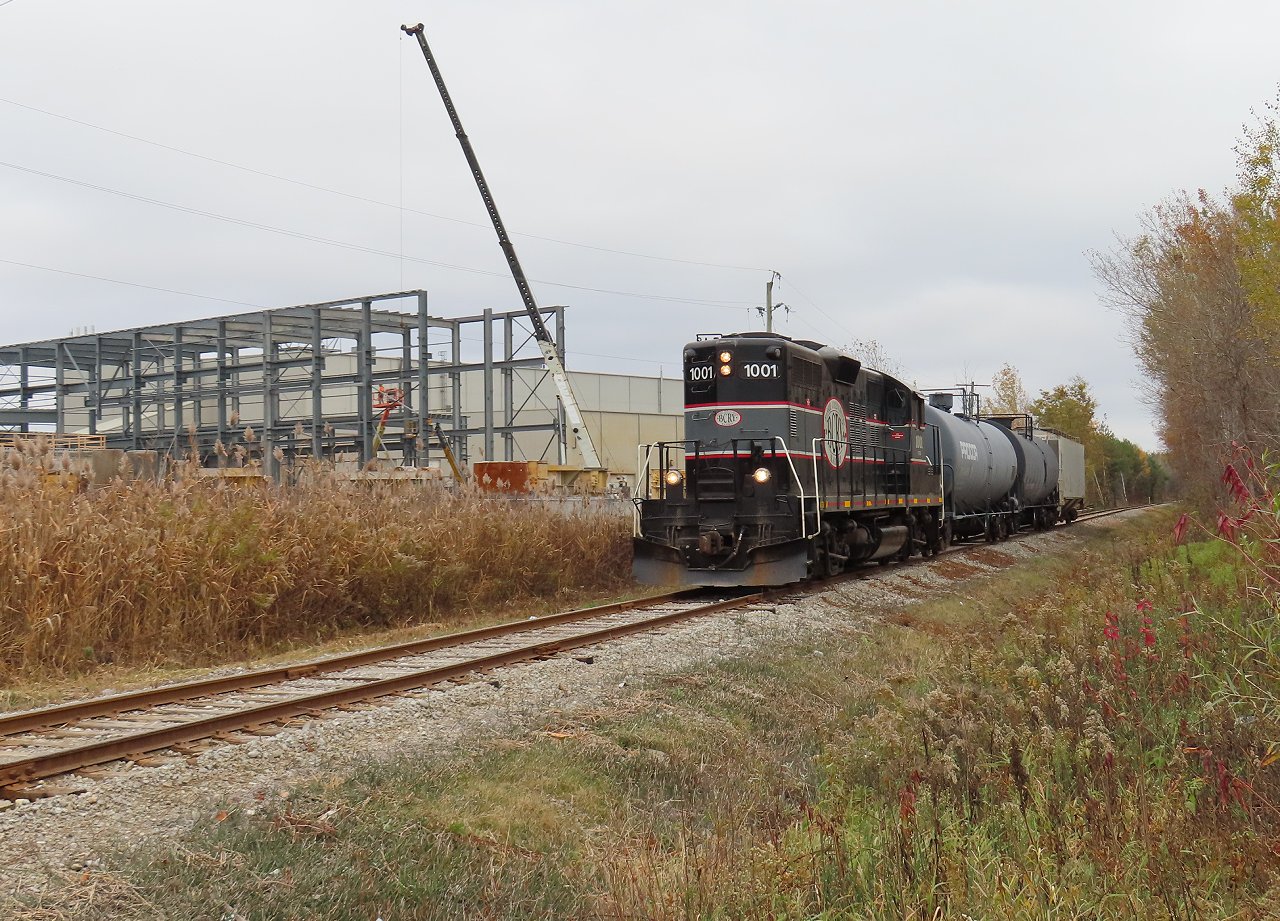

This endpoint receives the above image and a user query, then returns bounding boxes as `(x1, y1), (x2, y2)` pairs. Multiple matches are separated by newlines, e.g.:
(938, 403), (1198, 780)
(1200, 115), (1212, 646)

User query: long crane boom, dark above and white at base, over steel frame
(401, 23), (600, 469)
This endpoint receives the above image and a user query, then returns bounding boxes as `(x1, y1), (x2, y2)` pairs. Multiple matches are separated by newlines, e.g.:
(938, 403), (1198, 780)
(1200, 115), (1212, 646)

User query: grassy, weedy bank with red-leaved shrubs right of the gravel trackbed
(35, 498), (1280, 920)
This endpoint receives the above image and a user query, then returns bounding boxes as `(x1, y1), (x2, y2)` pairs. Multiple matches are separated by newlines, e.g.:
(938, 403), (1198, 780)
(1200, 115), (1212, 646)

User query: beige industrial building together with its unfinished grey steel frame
(0, 290), (682, 477)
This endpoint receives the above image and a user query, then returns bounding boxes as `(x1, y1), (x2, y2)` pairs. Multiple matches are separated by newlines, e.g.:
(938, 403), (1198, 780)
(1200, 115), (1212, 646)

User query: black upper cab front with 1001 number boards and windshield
(685, 339), (786, 405)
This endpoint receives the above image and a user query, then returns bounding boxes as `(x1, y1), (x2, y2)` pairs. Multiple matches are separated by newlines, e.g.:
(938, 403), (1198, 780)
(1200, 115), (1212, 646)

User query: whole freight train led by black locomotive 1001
(634, 333), (1083, 586)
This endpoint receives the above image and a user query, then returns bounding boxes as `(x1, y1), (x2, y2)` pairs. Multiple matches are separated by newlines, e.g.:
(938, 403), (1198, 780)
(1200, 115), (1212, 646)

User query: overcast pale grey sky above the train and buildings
(0, 0), (1280, 448)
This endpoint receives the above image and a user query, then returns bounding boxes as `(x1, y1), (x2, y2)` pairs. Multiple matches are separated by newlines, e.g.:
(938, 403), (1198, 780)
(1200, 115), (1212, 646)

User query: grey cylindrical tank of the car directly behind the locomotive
(924, 402), (1018, 516)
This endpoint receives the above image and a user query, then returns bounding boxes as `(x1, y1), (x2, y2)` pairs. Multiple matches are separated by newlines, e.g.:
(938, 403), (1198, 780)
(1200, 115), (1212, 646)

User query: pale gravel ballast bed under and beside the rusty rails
(0, 503), (1157, 890)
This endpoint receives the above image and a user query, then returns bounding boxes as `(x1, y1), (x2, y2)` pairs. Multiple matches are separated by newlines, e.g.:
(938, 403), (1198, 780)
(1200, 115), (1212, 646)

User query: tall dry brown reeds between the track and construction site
(0, 443), (630, 681)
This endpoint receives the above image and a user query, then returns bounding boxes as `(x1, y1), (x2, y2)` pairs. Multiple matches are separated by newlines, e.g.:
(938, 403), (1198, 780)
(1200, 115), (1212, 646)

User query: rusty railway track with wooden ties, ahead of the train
(0, 498), (1129, 798)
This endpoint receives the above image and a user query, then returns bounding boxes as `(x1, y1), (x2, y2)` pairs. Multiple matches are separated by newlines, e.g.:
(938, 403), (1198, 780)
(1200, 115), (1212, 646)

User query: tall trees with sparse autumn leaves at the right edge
(1092, 102), (1280, 507)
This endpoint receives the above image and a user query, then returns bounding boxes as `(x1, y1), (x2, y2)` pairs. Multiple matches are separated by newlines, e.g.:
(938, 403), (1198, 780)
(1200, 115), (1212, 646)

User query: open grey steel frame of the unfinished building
(0, 290), (564, 477)
